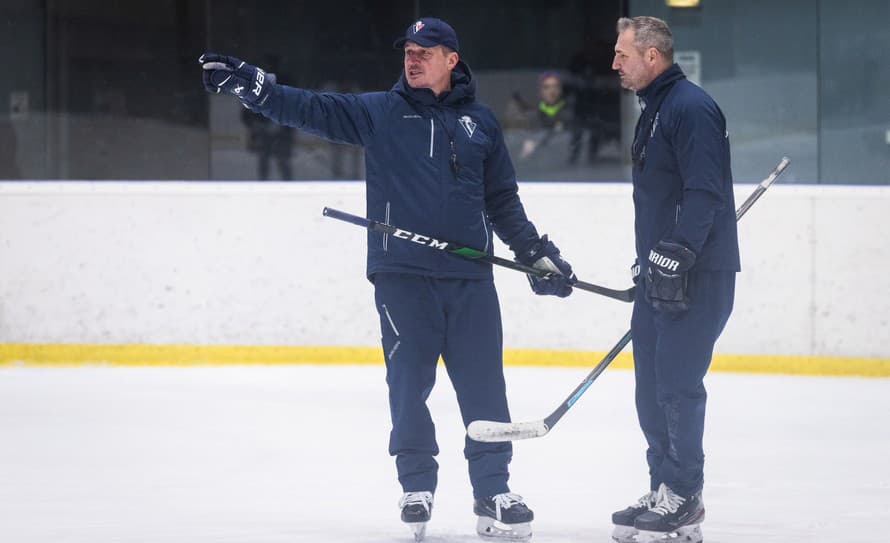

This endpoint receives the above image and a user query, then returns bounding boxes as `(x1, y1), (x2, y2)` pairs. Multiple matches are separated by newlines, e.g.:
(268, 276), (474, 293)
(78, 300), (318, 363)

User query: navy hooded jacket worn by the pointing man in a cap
(258, 62), (538, 278)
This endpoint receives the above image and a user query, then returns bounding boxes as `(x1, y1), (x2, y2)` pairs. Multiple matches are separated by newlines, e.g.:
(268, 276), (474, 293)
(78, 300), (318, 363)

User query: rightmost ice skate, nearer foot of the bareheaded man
(634, 484), (705, 543)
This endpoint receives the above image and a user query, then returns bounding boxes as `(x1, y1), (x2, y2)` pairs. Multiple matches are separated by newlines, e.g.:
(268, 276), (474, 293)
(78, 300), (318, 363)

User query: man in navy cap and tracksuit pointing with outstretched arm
(199, 14), (576, 538)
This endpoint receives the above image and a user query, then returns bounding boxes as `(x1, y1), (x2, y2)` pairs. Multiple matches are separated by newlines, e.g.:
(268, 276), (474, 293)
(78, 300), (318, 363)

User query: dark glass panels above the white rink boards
(0, 0), (890, 184)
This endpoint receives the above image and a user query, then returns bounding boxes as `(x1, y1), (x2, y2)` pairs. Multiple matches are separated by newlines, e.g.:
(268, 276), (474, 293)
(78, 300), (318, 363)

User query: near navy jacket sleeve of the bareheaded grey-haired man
(671, 97), (731, 254)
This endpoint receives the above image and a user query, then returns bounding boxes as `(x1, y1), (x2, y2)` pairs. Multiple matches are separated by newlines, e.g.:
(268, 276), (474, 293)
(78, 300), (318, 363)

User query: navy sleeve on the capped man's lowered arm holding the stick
(483, 117), (538, 254)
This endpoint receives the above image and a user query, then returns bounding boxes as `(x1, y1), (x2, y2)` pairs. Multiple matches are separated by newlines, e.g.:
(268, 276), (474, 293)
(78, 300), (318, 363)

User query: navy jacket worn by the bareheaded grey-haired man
(632, 64), (740, 273)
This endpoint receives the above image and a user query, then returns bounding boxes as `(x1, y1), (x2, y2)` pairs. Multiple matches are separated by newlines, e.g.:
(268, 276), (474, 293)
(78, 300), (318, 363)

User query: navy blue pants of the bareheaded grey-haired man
(631, 272), (735, 496)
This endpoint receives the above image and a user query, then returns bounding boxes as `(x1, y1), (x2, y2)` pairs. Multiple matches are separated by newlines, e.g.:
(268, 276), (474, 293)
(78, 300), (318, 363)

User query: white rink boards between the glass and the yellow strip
(0, 182), (890, 357)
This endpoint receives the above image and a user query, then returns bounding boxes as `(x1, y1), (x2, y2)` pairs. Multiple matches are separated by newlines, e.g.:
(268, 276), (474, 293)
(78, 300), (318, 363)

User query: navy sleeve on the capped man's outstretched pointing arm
(256, 85), (385, 145)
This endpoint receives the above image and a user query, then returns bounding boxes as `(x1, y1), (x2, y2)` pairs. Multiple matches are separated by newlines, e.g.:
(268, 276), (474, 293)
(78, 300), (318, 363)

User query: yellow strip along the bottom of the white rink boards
(0, 343), (890, 377)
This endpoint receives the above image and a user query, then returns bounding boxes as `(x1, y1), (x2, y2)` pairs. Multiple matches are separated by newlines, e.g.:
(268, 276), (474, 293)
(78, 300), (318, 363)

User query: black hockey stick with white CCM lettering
(322, 207), (634, 302)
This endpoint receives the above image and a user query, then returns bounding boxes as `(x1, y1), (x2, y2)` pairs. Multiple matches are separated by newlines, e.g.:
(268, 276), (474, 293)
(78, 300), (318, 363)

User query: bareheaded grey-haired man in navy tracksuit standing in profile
(612, 17), (740, 542)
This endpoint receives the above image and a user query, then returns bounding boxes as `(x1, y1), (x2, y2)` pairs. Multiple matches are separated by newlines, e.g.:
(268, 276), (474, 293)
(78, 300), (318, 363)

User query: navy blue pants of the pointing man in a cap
(374, 273), (513, 497)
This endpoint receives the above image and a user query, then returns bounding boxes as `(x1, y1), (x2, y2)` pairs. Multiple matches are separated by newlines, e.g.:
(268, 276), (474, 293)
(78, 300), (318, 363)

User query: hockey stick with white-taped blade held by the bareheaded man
(467, 157), (791, 442)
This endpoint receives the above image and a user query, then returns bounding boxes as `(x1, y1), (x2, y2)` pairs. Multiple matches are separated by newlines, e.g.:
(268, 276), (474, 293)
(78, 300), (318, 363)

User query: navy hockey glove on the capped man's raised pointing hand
(198, 53), (275, 107)
